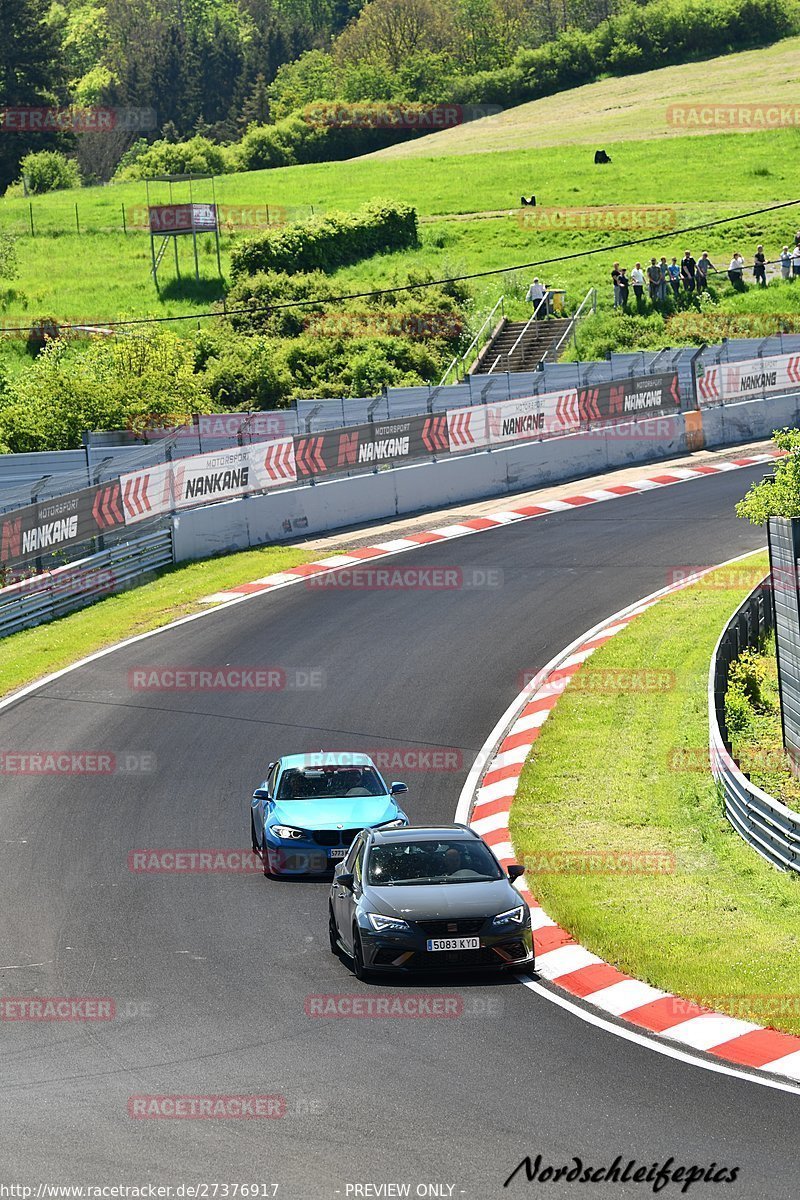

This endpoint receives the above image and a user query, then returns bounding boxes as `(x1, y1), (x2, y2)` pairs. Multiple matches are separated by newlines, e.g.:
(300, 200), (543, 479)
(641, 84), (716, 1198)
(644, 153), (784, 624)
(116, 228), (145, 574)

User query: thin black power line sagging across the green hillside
(4, 199), (800, 334)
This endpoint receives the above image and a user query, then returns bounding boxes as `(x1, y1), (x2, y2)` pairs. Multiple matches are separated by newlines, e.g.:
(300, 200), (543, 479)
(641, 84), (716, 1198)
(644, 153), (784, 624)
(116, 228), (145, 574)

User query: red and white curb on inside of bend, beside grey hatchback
(456, 556), (800, 1080)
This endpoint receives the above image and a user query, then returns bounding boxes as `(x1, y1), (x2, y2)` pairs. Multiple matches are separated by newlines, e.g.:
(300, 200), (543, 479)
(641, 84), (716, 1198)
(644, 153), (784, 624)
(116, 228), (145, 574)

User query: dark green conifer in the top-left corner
(0, 0), (65, 192)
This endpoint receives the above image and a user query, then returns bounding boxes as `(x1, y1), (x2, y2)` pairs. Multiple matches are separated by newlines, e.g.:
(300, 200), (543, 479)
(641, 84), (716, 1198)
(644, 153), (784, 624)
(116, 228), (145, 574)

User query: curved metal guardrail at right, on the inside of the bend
(709, 580), (800, 872)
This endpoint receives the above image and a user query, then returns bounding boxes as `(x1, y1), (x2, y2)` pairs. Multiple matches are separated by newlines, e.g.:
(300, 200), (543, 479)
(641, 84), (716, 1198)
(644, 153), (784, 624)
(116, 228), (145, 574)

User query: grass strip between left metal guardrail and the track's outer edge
(0, 546), (314, 696)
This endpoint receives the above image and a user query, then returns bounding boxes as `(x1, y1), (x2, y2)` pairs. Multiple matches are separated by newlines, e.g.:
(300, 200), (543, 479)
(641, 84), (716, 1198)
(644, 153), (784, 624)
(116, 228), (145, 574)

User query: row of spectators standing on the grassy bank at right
(612, 237), (800, 308)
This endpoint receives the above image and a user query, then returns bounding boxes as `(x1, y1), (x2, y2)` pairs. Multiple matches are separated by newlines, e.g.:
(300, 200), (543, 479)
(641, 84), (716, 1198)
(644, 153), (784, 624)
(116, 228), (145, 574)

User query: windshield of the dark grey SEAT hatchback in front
(367, 838), (503, 887)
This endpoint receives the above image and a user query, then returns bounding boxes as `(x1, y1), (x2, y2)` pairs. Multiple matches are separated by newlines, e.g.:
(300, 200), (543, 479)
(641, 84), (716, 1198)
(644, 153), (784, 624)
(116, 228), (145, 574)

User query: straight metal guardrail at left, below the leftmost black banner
(0, 526), (174, 637)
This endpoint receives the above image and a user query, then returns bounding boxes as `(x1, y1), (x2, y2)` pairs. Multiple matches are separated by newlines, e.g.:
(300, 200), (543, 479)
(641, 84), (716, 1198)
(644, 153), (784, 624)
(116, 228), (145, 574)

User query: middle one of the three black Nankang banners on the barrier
(294, 413), (450, 476)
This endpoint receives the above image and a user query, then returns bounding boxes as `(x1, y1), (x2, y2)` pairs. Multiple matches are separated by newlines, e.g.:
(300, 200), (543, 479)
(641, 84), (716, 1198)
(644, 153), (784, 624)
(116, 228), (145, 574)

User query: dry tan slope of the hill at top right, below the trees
(359, 37), (800, 161)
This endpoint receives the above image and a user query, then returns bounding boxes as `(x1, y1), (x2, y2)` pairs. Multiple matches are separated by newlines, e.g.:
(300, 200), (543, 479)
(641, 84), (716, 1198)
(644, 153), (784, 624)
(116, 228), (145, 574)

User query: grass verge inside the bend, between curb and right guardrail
(511, 554), (800, 1033)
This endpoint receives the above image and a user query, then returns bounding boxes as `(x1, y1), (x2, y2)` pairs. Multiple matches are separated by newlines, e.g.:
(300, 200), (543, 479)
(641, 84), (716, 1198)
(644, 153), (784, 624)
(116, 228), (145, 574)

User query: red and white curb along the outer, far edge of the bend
(201, 451), (777, 604)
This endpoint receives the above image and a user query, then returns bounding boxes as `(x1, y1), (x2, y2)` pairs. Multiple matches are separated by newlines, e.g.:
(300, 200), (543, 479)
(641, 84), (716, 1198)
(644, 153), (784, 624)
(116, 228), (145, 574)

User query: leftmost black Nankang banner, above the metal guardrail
(0, 480), (125, 566)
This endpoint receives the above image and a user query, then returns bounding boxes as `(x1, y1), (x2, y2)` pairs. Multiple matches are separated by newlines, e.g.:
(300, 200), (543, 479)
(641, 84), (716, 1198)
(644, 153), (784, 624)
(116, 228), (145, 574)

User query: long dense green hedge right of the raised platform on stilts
(230, 200), (419, 278)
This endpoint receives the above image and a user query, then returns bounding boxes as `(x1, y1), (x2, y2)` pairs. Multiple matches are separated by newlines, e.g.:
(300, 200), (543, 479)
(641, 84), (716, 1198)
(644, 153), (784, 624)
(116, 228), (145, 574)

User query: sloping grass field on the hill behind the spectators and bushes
(0, 45), (800, 372)
